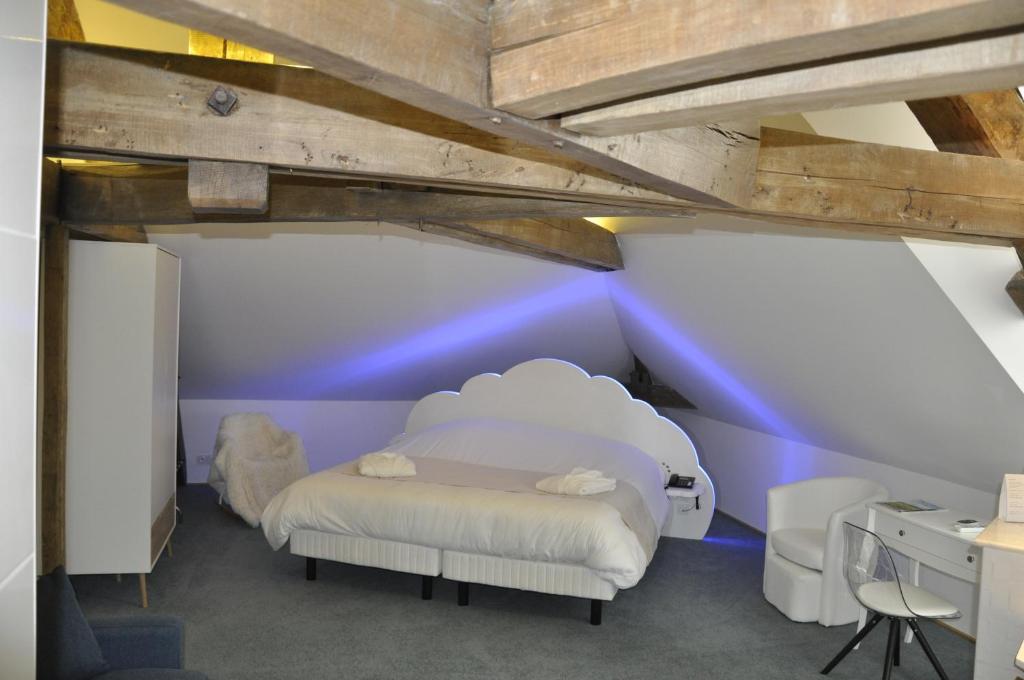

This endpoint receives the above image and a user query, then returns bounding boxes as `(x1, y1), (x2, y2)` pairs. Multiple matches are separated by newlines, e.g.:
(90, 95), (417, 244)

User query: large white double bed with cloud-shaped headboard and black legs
(262, 359), (715, 624)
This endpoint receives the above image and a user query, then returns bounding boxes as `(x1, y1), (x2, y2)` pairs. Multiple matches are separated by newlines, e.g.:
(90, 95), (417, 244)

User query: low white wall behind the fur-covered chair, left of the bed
(181, 399), (416, 483)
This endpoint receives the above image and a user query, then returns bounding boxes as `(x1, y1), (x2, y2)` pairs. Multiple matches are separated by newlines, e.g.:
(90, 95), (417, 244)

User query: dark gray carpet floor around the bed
(74, 485), (974, 680)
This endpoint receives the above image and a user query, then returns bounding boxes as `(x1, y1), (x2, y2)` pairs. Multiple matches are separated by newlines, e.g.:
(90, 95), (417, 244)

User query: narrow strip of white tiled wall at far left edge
(0, 0), (46, 680)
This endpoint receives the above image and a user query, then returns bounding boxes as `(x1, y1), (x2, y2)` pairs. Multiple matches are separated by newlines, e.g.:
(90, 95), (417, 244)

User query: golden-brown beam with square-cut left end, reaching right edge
(752, 128), (1024, 240)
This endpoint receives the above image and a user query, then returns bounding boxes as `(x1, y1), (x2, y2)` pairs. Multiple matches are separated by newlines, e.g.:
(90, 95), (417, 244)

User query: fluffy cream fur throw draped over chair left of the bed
(208, 413), (309, 526)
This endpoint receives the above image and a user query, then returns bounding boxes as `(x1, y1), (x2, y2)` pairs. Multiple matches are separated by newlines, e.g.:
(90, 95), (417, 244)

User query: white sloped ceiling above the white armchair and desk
(608, 216), (1024, 493)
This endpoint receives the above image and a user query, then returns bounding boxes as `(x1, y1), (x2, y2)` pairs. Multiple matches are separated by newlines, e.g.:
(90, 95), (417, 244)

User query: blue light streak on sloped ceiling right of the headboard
(608, 279), (803, 441)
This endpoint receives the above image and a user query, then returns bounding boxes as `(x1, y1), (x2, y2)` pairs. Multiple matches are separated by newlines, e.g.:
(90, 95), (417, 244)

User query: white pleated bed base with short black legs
(290, 529), (617, 626)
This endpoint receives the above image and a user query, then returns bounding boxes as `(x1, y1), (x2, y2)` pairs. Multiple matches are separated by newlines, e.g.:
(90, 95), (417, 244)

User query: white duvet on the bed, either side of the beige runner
(262, 420), (668, 588)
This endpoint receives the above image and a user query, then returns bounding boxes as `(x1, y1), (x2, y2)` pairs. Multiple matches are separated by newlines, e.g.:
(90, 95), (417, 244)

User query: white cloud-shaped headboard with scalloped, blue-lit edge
(406, 358), (715, 536)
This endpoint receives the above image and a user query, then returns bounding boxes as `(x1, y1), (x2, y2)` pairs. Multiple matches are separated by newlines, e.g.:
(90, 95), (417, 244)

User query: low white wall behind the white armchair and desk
(666, 409), (996, 635)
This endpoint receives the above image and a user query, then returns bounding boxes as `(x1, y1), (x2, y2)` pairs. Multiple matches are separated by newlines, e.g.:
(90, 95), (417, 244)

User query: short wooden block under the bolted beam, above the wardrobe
(188, 159), (270, 215)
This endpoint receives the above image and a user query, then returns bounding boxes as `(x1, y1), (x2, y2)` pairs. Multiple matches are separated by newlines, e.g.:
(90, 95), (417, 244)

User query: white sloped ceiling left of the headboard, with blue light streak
(148, 223), (630, 400)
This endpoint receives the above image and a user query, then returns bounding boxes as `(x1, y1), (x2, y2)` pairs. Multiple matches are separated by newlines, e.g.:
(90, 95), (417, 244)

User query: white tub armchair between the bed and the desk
(764, 477), (889, 626)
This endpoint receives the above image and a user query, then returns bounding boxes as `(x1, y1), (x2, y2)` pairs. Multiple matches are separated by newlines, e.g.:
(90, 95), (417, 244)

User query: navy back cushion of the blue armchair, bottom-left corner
(36, 566), (108, 680)
